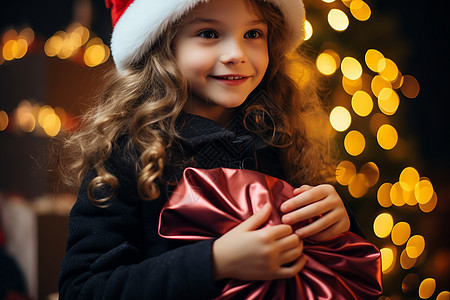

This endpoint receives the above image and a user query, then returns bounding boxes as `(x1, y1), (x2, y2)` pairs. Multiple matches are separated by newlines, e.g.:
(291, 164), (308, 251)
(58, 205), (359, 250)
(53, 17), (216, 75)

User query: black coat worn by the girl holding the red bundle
(59, 114), (360, 299)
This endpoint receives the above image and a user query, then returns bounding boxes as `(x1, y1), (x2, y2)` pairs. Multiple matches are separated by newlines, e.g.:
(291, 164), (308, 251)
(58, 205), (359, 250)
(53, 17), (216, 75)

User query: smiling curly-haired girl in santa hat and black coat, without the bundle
(59, 0), (372, 299)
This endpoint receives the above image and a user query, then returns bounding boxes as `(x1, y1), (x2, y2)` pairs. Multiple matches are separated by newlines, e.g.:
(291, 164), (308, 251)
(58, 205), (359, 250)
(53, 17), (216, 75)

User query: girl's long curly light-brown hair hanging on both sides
(59, 0), (334, 205)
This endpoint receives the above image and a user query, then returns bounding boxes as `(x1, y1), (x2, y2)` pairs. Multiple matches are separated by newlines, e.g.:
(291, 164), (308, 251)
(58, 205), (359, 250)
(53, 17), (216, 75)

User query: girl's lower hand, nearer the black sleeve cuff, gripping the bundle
(213, 204), (306, 280)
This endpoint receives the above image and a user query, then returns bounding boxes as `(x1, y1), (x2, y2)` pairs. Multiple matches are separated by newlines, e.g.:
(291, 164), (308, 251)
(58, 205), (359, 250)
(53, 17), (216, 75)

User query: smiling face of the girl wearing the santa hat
(174, 0), (269, 122)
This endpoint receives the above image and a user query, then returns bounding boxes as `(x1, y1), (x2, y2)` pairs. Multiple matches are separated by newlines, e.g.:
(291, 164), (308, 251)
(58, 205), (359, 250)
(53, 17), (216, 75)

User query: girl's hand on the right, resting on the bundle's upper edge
(280, 184), (350, 241)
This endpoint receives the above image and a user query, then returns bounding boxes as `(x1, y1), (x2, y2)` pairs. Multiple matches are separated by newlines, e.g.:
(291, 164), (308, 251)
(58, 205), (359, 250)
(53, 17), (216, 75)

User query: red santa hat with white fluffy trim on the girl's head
(105, 0), (305, 71)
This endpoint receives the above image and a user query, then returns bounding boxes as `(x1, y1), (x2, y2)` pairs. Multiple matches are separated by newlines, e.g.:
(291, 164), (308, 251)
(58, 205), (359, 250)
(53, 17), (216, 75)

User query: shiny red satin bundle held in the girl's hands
(159, 168), (382, 300)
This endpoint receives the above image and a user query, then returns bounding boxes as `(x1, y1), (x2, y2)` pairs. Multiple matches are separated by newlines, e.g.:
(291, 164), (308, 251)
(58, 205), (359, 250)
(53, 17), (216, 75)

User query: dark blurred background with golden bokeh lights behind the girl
(0, 0), (450, 300)
